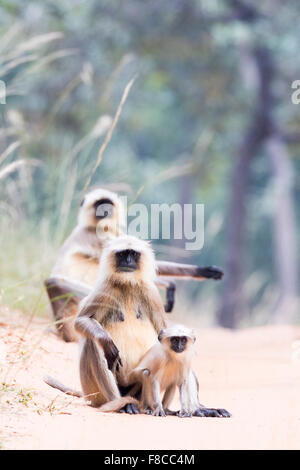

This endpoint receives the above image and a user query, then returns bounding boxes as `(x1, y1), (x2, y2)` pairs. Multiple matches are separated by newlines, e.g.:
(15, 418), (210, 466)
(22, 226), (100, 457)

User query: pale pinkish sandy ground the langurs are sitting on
(0, 313), (300, 450)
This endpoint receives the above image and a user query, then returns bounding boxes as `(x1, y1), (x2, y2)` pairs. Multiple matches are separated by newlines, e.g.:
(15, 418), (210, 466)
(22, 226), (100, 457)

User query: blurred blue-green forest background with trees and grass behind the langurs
(0, 0), (300, 328)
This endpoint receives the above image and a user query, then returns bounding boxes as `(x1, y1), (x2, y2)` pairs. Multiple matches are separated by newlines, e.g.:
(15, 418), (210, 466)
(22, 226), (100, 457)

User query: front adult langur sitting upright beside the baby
(75, 236), (166, 413)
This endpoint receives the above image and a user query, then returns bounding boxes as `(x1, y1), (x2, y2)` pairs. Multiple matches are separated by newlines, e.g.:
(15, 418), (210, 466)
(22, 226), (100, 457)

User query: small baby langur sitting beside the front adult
(132, 325), (230, 417)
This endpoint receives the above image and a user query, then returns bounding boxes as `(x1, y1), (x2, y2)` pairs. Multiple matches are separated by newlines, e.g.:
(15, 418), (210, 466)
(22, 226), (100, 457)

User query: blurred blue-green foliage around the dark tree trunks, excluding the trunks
(0, 0), (300, 324)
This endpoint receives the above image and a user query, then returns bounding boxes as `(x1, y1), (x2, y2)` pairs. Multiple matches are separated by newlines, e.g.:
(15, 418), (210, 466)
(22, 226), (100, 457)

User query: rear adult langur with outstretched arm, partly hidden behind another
(45, 188), (223, 342)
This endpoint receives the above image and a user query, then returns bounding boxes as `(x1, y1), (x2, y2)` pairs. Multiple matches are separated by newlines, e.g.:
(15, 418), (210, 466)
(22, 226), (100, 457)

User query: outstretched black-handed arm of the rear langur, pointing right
(156, 261), (223, 281)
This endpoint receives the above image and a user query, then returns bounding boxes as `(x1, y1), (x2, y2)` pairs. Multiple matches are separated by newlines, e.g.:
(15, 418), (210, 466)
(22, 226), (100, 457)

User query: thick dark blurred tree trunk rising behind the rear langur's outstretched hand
(218, 46), (273, 328)
